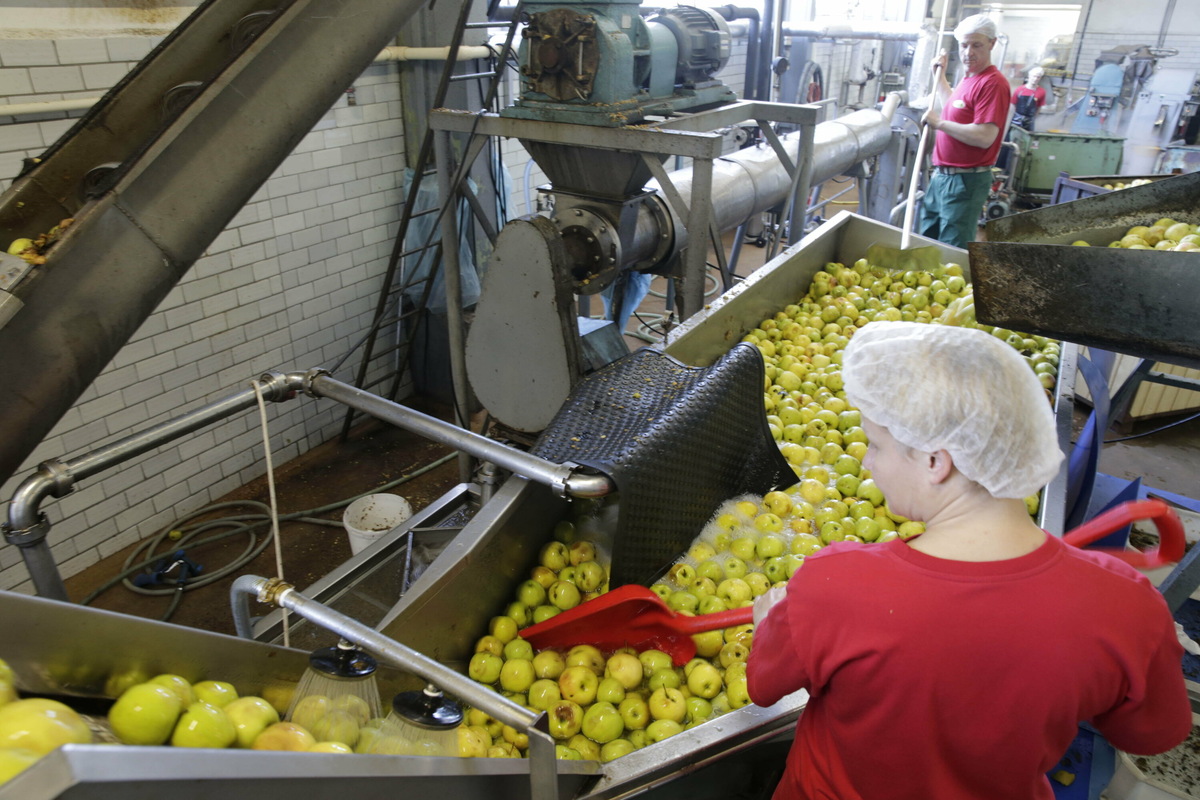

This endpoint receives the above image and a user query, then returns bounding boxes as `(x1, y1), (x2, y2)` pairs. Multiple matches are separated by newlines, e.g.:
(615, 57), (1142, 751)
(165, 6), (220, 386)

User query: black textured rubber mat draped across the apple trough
(533, 343), (796, 587)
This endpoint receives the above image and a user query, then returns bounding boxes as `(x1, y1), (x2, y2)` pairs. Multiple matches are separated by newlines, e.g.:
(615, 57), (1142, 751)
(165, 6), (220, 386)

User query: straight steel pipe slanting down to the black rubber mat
(304, 369), (614, 498)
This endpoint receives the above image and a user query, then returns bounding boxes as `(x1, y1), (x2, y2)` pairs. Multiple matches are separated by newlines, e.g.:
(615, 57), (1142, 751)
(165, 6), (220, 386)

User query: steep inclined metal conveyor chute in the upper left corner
(0, 0), (420, 480)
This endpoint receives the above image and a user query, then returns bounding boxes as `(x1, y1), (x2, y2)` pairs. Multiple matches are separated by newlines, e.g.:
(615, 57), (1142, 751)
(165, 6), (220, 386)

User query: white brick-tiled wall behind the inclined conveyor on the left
(0, 36), (406, 591)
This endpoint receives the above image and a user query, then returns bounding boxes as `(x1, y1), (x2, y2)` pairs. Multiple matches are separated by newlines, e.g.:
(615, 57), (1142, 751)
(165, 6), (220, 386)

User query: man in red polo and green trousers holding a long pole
(919, 14), (1009, 247)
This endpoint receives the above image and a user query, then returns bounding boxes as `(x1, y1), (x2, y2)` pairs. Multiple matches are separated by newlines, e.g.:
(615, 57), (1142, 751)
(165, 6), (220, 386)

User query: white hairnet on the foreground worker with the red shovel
(841, 321), (1063, 498)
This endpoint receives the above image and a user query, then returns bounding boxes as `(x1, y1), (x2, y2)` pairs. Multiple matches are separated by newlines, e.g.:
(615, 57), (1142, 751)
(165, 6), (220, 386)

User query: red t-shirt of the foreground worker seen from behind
(748, 532), (1192, 800)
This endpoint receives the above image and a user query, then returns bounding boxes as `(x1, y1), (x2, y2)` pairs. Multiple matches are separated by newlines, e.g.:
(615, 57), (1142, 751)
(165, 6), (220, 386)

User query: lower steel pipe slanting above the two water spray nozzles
(241, 576), (558, 800)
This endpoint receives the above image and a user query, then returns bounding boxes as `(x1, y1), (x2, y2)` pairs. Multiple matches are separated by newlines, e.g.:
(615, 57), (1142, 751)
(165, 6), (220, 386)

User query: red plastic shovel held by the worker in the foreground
(521, 500), (1184, 666)
